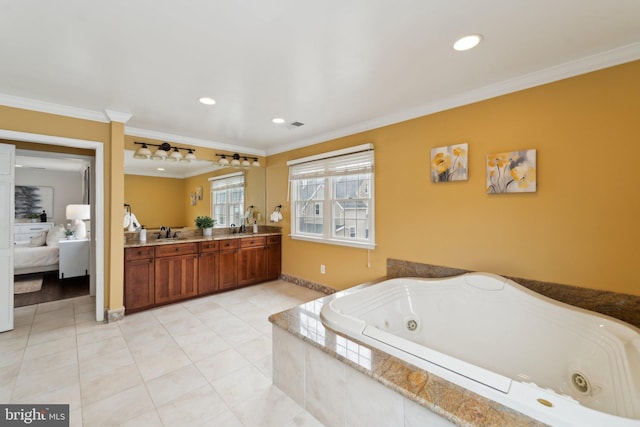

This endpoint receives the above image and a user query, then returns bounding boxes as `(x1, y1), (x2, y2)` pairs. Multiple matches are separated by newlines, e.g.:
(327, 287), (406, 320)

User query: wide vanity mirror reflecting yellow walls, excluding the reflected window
(124, 150), (271, 229)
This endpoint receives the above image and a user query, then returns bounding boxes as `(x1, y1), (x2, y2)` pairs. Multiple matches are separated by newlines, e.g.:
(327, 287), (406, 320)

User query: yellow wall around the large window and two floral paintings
(267, 61), (640, 295)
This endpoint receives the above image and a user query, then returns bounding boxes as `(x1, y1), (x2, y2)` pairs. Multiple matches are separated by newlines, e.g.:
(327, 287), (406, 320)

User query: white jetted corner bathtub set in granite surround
(320, 273), (640, 427)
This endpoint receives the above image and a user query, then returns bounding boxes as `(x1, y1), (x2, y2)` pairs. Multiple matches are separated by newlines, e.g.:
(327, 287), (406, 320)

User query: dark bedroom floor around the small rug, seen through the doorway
(13, 271), (89, 307)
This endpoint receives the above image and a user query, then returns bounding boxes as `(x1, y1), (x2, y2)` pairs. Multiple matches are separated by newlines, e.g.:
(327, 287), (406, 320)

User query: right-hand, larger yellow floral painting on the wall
(487, 150), (536, 194)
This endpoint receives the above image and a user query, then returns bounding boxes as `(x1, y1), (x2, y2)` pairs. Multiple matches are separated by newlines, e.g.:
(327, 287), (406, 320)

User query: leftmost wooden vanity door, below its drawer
(124, 258), (155, 313)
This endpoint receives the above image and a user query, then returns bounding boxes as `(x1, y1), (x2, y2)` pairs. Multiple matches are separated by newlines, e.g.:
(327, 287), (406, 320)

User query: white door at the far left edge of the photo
(0, 144), (16, 332)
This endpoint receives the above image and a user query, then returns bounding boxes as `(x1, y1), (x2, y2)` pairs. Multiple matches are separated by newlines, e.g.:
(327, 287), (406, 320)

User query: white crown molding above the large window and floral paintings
(266, 42), (640, 155)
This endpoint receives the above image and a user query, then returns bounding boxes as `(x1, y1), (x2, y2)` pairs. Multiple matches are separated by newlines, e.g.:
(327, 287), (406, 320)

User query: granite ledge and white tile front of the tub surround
(269, 294), (544, 427)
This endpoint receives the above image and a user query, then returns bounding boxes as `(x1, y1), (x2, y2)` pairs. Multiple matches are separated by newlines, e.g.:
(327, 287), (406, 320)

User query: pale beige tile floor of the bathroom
(0, 281), (322, 427)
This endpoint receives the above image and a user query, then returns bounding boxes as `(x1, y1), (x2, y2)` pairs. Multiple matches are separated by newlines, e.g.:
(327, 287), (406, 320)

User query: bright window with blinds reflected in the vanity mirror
(209, 172), (244, 227)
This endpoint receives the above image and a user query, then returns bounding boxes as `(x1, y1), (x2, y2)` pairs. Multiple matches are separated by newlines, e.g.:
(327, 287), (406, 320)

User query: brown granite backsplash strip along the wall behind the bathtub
(387, 258), (640, 328)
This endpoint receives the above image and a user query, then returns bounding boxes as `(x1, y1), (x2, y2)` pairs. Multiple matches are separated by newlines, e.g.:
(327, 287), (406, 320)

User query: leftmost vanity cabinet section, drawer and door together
(124, 247), (155, 312)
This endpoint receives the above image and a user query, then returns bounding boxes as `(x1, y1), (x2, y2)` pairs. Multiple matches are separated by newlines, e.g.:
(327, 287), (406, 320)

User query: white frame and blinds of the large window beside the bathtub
(287, 144), (376, 249)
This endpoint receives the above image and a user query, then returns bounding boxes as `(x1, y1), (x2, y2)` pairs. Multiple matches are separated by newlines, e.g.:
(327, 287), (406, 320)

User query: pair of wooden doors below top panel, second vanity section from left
(155, 254), (198, 304)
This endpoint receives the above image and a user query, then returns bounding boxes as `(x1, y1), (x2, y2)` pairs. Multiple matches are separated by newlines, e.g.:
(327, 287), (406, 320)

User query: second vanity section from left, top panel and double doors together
(155, 243), (198, 304)
